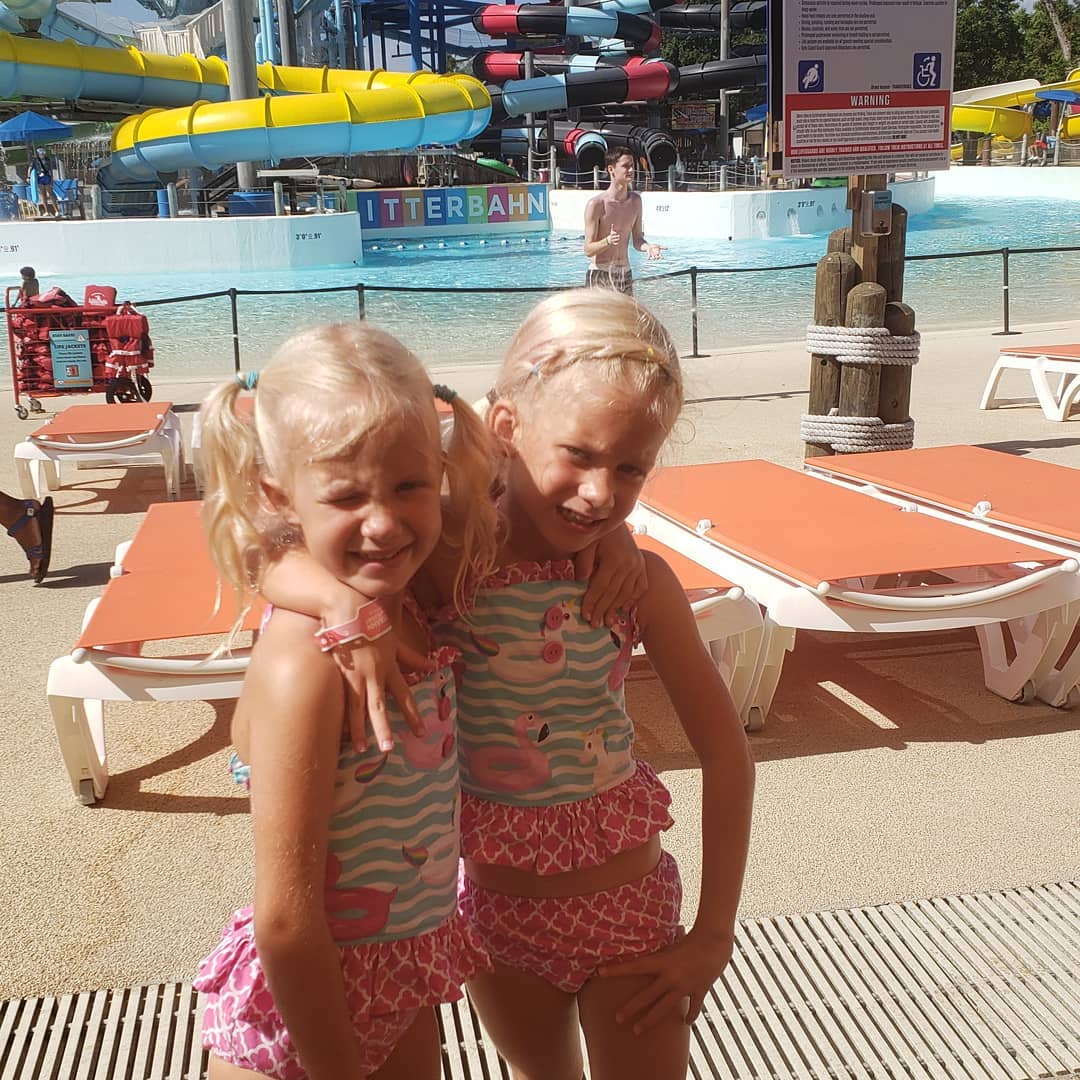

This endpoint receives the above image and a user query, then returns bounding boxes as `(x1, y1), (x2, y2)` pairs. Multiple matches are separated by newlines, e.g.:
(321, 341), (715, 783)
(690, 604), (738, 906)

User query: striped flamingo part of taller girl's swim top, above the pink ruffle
(432, 559), (637, 806)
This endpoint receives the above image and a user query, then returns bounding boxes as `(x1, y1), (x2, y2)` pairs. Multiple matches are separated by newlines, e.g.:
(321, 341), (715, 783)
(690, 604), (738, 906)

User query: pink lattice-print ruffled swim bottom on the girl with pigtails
(194, 907), (490, 1080)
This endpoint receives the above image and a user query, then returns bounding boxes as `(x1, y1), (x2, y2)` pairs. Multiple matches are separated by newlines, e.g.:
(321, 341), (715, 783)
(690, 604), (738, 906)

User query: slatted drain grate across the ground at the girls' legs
(0, 882), (1080, 1080)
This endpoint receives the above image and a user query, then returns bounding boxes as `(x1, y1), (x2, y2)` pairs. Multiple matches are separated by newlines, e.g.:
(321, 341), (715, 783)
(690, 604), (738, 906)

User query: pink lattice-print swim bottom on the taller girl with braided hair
(458, 851), (683, 994)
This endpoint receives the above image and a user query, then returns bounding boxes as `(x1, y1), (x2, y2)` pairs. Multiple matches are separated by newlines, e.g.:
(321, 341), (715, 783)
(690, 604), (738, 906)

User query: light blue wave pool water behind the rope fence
(33, 197), (1080, 384)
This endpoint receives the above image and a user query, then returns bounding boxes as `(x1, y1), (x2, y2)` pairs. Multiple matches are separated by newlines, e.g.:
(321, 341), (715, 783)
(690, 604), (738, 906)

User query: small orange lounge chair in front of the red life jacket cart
(15, 402), (184, 499)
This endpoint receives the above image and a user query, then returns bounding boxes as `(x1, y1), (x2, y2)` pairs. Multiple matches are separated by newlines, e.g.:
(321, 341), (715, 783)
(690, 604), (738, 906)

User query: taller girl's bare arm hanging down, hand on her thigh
(608, 552), (754, 1026)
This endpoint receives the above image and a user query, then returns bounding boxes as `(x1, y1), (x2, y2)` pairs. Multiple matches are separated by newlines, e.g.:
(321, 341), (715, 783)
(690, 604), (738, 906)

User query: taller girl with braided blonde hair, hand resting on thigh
(435, 289), (754, 1080)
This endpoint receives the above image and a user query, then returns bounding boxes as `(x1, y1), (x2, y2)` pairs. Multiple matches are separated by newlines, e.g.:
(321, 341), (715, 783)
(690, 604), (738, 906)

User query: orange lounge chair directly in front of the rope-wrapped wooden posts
(806, 446), (1080, 706)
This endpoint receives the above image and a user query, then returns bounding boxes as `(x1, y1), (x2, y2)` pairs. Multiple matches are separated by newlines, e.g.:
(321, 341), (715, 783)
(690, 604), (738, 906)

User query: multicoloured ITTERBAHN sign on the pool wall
(356, 184), (549, 237)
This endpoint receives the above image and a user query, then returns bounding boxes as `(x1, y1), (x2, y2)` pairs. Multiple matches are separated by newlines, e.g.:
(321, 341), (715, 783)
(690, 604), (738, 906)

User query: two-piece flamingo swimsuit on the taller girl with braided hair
(434, 559), (681, 993)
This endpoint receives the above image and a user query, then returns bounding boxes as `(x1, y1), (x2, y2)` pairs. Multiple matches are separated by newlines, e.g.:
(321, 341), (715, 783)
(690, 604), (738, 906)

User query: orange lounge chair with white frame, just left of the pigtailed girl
(46, 502), (262, 805)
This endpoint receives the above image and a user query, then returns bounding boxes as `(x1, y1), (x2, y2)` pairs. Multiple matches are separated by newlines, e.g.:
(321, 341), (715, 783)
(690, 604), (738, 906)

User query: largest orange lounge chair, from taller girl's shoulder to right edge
(631, 461), (1080, 715)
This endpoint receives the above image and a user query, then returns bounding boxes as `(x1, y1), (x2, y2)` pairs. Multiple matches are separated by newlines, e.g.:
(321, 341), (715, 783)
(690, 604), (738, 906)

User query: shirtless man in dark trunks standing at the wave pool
(585, 147), (663, 294)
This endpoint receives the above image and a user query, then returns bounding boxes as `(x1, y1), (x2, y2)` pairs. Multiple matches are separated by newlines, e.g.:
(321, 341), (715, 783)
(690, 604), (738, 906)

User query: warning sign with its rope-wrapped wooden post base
(770, 0), (956, 457)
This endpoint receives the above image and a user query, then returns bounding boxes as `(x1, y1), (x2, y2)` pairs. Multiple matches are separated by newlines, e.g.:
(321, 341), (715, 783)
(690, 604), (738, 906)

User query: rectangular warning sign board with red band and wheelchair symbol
(783, 0), (956, 179)
